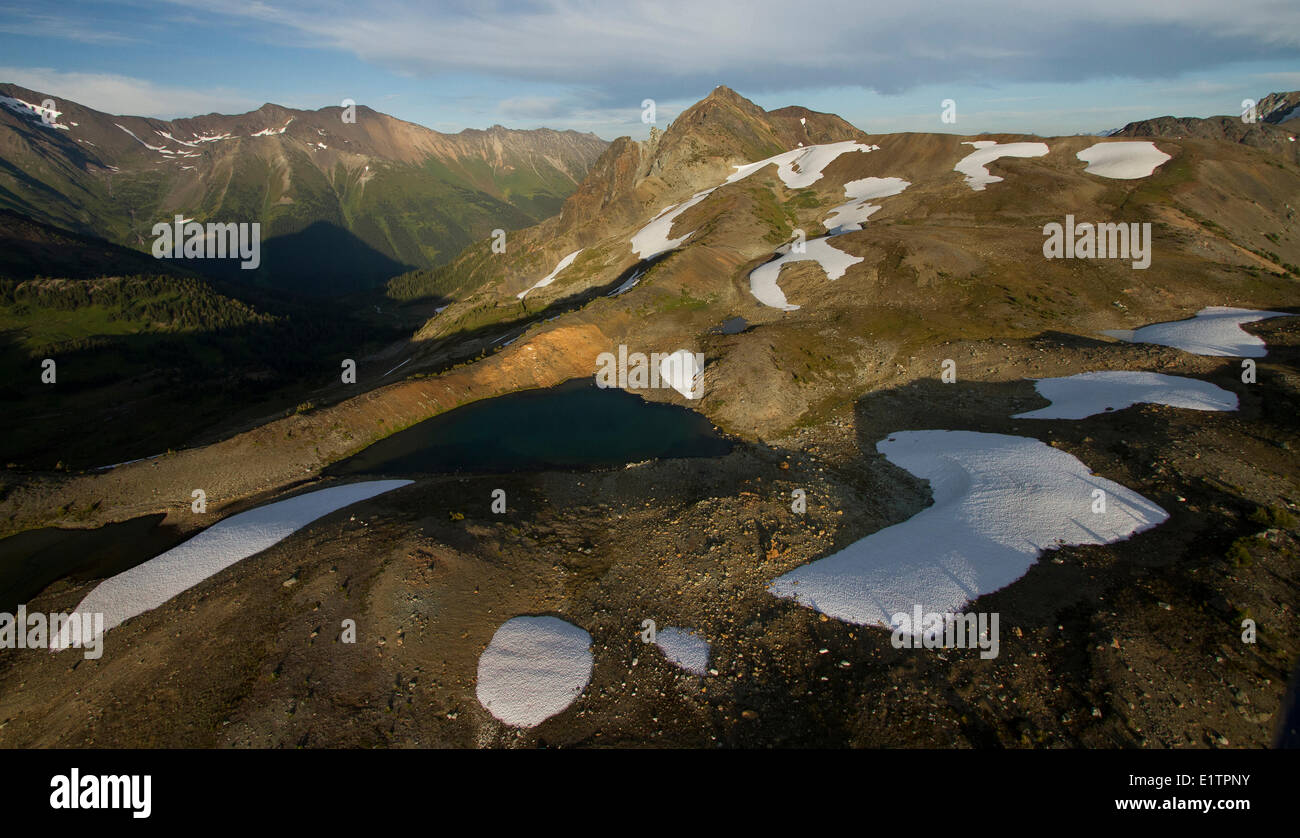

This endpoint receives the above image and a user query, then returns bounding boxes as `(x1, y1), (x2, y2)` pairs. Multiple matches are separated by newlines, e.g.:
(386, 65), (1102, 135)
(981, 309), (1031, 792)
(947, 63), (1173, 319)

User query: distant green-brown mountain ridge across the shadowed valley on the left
(0, 84), (607, 292)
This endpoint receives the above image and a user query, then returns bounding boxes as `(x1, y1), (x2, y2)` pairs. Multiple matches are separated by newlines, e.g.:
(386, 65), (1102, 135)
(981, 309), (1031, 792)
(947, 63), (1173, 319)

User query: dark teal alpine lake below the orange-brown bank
(326, 378), (732, 476)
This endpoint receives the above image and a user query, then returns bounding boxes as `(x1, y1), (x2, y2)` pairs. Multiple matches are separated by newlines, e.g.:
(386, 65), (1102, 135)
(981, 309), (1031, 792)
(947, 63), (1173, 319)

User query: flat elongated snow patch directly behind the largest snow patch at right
(1011, 372), (1236, 418)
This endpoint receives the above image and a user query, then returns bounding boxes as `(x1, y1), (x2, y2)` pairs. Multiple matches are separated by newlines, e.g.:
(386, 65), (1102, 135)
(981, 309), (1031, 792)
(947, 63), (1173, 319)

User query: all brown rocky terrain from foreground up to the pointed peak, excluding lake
(0, 88), (1300, 747)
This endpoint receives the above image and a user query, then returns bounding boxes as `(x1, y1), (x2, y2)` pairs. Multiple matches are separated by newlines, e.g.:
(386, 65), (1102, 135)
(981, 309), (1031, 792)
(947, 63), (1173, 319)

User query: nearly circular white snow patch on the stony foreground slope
(477, 617), (592, 728)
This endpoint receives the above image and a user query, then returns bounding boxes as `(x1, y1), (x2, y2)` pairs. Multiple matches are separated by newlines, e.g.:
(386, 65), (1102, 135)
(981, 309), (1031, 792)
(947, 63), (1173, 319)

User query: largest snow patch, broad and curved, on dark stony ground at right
(768, 430), (1169, 628)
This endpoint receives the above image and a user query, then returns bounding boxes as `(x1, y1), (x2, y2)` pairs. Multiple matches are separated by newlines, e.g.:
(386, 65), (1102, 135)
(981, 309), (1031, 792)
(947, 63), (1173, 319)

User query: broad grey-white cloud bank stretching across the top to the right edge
(172, 0), (1300, 98)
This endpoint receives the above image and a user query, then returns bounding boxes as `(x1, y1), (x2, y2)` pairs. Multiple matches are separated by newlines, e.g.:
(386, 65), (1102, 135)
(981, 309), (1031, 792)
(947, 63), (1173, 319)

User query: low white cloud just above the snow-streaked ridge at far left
(0, 66), (261, 120)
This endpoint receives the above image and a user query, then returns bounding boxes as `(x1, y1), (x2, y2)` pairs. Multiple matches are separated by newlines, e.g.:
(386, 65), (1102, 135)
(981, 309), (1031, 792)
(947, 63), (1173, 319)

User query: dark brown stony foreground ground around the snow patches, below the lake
(0, 318), (1300, 747)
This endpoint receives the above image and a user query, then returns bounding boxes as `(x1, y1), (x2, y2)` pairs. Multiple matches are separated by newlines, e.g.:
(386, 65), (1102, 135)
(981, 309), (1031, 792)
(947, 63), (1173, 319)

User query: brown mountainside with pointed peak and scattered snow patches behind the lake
(389, 87), (1300, 444)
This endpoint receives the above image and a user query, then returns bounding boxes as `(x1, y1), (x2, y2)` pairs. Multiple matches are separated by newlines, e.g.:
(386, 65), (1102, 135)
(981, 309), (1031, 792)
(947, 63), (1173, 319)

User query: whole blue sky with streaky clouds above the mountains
(0, 0), (1300, 139)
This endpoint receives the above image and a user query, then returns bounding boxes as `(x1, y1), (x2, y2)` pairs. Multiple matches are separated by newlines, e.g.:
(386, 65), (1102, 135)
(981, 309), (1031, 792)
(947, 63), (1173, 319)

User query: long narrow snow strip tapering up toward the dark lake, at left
(60, 481), (412, 644)
